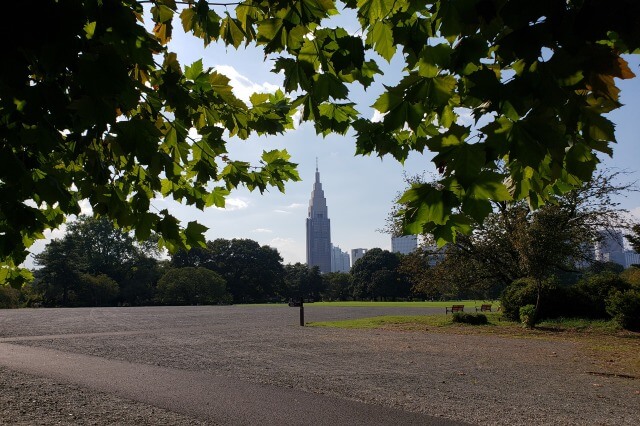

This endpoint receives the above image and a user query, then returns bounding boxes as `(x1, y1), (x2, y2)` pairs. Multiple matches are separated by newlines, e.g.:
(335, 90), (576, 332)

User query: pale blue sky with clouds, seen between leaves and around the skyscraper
(25, 8), (640, 267)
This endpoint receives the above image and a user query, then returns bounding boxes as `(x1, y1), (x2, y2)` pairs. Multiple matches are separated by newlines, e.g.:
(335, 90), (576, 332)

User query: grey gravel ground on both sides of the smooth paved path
(0, 306), (640, 425)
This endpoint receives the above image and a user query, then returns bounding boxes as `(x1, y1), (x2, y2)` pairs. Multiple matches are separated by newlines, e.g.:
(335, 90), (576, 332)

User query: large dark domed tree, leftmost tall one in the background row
(34, 216), (160, 306)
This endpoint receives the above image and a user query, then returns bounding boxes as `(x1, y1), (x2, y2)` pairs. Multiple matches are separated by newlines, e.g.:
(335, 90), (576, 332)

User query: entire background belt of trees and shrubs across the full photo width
(0, 210), (640, 329)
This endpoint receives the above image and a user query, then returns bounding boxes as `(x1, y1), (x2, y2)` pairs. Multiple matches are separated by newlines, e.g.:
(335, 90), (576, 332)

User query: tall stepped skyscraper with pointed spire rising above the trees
(307, 164), (331, 273)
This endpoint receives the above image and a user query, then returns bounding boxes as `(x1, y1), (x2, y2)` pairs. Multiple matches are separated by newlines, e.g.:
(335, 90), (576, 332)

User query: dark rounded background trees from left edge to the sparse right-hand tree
(0, 216), (421, 307)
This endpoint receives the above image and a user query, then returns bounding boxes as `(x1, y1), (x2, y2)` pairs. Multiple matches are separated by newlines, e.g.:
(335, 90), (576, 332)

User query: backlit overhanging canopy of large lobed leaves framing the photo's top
(0, 0), (640, 282)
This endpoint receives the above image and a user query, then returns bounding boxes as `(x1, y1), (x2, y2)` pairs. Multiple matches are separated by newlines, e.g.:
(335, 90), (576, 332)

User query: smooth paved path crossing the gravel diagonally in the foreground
(0, 339), (461, 426)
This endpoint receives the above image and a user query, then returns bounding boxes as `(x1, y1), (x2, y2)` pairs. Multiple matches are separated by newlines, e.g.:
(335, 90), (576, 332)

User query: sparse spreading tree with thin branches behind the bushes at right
(387, 170), (635, 304)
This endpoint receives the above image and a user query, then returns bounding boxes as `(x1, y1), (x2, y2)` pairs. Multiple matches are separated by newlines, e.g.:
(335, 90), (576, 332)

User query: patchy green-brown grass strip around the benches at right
(307, 312), (640, 380)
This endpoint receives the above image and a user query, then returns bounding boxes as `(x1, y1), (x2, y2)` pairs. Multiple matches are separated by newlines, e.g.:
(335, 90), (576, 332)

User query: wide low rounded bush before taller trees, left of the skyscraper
(157, 267), (229, 305)
